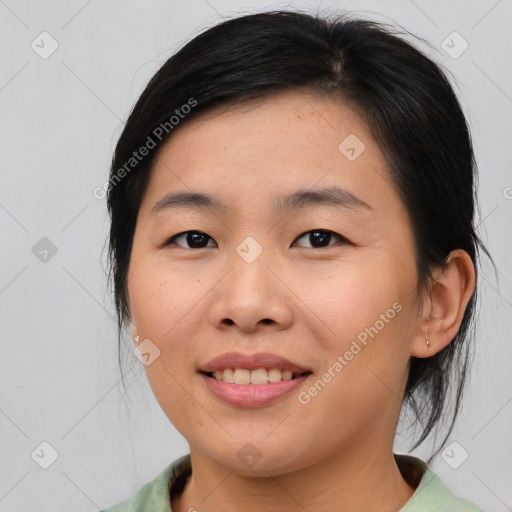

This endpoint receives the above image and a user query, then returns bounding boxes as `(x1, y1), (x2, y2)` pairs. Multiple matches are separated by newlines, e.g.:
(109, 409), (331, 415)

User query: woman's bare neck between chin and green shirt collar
(172, 447), (415, 512)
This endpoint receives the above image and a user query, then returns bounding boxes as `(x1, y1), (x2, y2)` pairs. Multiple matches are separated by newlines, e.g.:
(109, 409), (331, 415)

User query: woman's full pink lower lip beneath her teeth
(201, 373), (310, 407)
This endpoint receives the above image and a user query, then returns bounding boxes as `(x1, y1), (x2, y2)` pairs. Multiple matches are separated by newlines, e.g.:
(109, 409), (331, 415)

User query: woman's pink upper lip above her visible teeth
(199, 352), (311, 373)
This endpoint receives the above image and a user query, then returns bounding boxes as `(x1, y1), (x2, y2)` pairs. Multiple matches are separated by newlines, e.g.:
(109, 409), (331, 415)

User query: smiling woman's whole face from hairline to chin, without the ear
(128, 92), (428, 475)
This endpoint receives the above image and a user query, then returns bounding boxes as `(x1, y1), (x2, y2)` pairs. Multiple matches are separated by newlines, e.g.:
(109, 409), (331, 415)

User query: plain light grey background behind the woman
(0, 0), (512, 512)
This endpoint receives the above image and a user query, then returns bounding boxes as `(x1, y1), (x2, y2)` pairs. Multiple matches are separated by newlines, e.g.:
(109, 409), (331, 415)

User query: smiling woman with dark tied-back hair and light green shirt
(102, 12), (485, 512)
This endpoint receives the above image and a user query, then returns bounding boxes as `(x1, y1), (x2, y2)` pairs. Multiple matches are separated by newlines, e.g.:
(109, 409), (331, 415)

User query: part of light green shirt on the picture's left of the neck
(100, 454), (191, 512)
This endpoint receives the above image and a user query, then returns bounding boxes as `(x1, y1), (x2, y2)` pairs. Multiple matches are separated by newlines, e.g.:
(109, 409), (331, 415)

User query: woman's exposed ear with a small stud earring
(411, 249), (475, 358)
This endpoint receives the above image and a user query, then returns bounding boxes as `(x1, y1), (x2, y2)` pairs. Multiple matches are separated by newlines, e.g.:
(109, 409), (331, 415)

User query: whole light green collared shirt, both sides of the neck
(103, 454), (483, 512)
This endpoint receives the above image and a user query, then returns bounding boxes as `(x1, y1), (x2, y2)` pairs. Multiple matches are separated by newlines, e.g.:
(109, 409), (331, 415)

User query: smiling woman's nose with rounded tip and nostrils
(209, 254), (293, 334)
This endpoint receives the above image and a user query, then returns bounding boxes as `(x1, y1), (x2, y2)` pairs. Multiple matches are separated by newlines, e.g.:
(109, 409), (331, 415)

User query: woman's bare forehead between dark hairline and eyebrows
(141, 88), (399, 224)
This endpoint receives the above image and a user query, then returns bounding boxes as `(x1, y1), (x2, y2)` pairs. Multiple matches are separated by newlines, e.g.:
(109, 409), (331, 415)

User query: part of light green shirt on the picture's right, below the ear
(395, 454), (484, 512)
